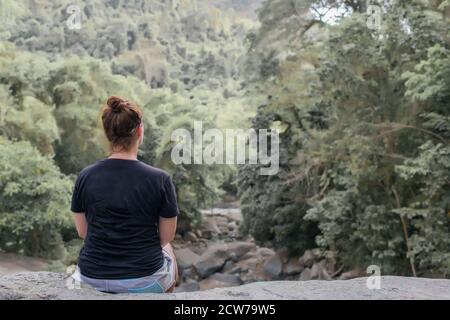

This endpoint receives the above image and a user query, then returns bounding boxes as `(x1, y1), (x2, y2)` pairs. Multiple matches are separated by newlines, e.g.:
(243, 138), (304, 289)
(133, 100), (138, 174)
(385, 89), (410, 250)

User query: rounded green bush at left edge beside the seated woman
(0, 137), (72, 258)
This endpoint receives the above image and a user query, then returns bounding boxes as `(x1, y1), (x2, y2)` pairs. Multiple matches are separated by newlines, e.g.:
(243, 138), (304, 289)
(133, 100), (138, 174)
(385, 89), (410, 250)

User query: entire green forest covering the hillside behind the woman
(0, 0), (450, 278)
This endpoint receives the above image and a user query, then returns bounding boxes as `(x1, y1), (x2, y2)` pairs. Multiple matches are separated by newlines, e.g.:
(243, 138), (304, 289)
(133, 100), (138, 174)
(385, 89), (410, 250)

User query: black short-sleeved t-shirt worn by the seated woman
(71, 159), (179, 279)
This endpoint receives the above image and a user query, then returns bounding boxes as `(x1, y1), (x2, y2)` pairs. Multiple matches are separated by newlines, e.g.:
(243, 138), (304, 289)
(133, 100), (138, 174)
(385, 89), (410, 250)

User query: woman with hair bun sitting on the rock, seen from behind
(71, 96), (179, 293)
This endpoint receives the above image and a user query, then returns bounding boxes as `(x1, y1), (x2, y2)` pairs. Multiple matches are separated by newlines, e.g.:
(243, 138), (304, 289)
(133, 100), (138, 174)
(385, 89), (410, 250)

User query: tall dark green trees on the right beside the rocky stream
(239, 0), (450, 276)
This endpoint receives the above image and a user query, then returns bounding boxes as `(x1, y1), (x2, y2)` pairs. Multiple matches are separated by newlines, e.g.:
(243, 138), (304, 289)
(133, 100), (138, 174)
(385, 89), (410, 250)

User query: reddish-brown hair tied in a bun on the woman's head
(102, 96), (142, 151)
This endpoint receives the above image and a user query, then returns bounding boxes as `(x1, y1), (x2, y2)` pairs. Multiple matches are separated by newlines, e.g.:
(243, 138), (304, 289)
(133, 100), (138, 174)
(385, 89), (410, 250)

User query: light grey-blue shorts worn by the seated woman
(72, 249), (175, 293)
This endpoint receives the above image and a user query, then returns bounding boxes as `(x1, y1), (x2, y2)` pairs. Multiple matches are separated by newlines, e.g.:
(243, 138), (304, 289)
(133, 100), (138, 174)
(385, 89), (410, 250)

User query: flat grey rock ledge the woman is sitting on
(0, 272), (450, 300)
